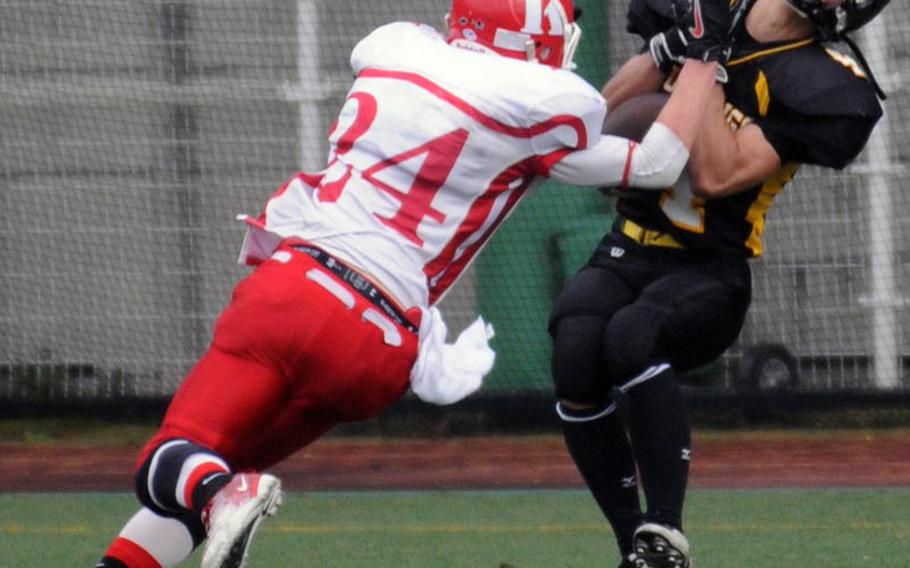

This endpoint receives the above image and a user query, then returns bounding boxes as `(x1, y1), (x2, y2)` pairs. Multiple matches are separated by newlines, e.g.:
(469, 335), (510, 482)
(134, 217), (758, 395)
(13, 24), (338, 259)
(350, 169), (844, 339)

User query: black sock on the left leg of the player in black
(562, 408), (642, 556)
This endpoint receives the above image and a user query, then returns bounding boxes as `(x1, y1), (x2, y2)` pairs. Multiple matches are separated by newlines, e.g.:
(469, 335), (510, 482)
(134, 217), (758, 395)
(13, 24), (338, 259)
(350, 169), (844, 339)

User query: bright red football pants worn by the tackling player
(138, 247), (419, 470)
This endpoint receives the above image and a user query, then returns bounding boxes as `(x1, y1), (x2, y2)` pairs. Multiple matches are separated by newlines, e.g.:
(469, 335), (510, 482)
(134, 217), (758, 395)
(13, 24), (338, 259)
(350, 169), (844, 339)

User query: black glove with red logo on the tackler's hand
(665, 0), (733, 65)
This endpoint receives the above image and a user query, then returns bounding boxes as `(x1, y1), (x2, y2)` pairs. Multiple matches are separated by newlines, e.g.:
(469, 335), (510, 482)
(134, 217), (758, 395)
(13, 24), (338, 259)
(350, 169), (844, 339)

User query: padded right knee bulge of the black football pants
(603, 304), (665, 386)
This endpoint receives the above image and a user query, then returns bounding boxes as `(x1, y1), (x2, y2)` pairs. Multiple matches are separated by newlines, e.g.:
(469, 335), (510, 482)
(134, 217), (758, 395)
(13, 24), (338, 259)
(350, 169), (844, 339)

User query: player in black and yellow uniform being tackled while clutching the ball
(550, 0), (888, 568)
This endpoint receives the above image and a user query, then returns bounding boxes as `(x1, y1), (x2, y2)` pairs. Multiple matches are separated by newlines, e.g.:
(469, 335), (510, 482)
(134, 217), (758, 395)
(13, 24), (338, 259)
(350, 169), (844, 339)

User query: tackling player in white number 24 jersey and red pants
(98, 0), (722, 568)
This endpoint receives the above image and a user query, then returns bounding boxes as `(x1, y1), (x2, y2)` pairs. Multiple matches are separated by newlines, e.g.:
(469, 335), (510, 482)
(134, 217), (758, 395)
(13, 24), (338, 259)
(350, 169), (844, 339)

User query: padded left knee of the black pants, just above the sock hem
(550, 316), (610, 405)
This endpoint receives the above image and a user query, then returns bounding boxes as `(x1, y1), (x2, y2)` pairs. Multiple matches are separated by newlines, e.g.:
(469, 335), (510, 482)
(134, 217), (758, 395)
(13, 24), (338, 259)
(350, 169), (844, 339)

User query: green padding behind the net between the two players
(477, 0), (613, 392)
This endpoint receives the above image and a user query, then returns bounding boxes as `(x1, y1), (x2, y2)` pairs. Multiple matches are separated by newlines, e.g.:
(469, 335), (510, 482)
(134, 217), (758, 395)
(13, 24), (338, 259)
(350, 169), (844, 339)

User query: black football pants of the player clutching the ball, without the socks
(549, 233), (752, 405)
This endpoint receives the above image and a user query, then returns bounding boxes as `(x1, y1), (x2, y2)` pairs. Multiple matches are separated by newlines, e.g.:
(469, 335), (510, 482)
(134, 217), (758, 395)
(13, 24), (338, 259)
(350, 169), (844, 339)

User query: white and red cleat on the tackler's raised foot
(201, 473), (281, 568)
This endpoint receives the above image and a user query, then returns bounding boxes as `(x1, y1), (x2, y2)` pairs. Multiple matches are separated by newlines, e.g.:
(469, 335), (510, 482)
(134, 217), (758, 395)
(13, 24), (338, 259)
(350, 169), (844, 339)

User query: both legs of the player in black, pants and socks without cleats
(550, 230), (751, 557)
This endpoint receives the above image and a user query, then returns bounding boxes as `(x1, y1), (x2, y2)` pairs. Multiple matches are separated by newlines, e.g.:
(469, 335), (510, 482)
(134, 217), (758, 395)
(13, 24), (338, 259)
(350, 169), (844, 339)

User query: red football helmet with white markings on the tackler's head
(446, 0), (581, 69)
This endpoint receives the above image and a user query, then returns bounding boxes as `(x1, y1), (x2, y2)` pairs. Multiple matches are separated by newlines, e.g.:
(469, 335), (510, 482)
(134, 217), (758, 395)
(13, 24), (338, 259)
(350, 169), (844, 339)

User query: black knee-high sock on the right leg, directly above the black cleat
(628, 367), (692, 530)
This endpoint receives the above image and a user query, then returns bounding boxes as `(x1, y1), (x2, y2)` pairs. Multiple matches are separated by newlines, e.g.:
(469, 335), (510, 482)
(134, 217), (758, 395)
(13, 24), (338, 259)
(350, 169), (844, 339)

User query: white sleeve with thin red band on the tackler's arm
(549, 122), (689, 189)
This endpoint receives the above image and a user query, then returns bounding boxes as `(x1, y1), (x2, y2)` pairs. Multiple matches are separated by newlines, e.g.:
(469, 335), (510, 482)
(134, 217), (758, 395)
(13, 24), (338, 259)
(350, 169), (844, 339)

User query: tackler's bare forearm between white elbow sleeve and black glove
(657, 59), (722, 150)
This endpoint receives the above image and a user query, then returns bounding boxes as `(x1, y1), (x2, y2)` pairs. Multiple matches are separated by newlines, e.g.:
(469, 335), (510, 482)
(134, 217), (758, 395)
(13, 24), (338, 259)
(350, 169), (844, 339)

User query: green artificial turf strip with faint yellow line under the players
(0, 488), (910, 568)
